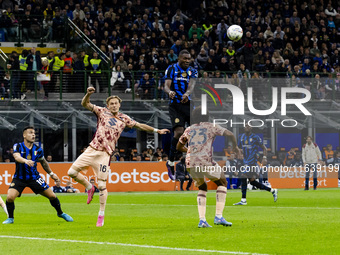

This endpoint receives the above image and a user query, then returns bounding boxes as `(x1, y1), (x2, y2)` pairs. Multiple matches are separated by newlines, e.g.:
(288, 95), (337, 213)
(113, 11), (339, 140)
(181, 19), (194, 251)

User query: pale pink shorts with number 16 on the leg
(71, 146), (111, 180)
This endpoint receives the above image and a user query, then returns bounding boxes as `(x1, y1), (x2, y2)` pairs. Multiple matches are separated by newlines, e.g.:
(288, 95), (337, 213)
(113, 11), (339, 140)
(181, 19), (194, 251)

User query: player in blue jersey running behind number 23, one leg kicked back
(234, 124), (277, 205)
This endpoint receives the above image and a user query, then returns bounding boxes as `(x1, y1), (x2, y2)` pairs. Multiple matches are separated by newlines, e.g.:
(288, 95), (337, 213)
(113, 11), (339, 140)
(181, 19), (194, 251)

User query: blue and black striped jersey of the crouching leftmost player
(13, 142), (44, 181)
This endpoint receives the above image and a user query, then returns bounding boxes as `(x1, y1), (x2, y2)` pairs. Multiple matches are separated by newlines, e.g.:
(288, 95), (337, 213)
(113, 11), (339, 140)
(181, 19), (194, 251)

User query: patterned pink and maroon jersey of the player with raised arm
(90, 105), (136, 155)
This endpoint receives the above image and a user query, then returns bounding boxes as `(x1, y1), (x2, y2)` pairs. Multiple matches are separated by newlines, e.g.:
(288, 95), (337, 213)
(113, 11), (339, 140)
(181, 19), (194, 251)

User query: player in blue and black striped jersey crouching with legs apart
(3, 127), (73, 224)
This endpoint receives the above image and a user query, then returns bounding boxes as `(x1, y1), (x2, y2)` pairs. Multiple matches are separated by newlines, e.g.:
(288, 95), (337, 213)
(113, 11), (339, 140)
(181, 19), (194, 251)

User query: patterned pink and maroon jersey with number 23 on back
(179, 122), (227, 168)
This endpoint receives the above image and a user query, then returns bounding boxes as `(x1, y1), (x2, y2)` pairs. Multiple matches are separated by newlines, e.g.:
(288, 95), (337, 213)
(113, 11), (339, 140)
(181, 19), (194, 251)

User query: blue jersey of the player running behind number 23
(237, 133), (263, 165)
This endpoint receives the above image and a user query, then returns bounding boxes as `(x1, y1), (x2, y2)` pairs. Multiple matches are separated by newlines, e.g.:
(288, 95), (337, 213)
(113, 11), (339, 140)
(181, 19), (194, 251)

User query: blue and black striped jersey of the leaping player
(164, 63), (198, 104)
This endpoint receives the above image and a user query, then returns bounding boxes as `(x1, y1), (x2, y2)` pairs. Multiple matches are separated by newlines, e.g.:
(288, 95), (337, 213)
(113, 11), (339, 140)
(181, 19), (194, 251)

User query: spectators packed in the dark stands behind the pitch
(0, 0), (340, 99)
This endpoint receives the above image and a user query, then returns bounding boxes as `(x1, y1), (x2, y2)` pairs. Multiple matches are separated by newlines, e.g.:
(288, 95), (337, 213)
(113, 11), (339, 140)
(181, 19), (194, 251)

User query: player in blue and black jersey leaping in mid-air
(164, 50), (198, 180)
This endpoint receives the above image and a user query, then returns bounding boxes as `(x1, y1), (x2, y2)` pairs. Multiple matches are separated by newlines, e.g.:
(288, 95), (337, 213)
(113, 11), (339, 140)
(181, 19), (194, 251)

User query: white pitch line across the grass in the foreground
(0, 235), (268, 255)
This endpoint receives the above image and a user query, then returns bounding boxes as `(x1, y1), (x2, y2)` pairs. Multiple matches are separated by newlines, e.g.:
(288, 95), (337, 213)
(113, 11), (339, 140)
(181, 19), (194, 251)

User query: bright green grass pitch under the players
(0, 189), (340, 255)
